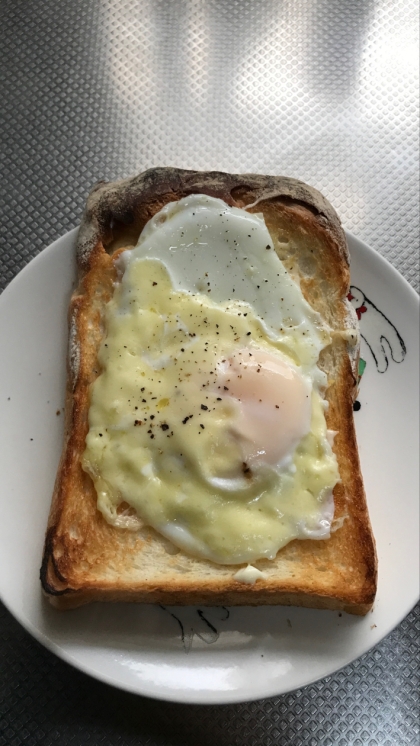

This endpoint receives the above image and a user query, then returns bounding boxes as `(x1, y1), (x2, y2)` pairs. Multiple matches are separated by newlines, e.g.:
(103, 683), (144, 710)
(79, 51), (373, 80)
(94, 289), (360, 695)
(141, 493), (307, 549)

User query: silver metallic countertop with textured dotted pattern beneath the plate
(0, 0), (420, 746)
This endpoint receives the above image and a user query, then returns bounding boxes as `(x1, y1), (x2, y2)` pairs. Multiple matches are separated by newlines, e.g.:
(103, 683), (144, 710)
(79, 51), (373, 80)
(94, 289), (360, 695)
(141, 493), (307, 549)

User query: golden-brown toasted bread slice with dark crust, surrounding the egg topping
(41, 168), (377, 614)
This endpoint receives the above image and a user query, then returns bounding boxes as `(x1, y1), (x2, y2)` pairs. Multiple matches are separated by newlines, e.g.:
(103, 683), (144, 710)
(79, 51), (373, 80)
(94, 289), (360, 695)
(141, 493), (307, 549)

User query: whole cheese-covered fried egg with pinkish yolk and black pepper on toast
(83, 195), (339, 564)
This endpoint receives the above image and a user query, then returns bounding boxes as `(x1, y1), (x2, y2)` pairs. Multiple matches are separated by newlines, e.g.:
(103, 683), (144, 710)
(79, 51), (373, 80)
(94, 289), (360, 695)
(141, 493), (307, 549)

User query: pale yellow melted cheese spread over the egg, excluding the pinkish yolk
(83, 196), (339, 564)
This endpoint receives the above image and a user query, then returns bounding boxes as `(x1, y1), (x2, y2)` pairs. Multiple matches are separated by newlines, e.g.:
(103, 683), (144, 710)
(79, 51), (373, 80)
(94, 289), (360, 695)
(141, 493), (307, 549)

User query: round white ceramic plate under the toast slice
(0, 231), (419, 703)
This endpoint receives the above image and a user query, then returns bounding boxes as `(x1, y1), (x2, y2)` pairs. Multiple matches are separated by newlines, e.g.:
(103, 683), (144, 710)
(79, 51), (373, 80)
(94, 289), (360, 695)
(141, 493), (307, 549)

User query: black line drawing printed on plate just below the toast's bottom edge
(159, 604), (229, 653)
